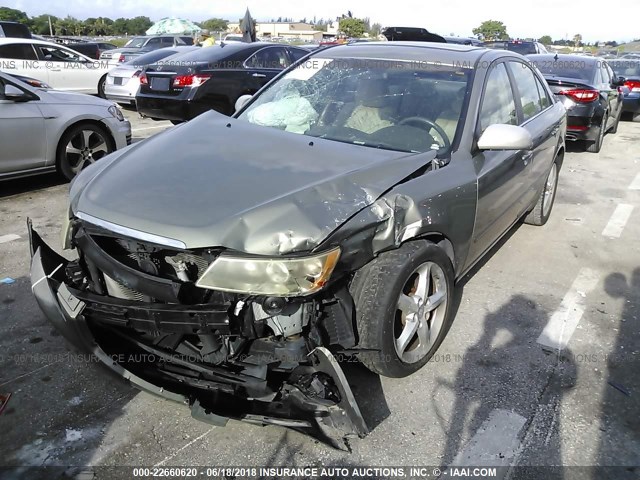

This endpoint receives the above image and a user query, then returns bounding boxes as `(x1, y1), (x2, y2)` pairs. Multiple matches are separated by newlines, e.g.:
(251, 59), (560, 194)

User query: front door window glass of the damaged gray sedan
(480, 63), (518, 131)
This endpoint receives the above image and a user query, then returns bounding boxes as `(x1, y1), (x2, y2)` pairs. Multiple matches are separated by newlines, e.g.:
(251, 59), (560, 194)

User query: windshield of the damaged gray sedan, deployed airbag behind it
(239, 57), (470, 152)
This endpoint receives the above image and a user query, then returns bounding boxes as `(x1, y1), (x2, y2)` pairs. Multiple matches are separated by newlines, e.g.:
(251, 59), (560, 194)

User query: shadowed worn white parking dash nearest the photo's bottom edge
(450, 409), (527, 467)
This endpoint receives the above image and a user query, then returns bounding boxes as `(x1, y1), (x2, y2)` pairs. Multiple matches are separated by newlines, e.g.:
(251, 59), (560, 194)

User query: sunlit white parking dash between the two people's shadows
(538, 268), (600, 351)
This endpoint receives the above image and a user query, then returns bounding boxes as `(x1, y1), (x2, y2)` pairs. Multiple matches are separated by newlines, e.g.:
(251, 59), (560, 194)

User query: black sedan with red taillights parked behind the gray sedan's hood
(136, 42), (309, 123)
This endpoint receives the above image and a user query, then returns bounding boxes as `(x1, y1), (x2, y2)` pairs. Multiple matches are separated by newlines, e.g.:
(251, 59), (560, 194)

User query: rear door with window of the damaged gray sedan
(507, 60), (562, 209)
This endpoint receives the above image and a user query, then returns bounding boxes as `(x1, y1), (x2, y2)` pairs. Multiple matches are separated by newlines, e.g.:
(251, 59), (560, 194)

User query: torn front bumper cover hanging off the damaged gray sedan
(28, 222), (368, 448)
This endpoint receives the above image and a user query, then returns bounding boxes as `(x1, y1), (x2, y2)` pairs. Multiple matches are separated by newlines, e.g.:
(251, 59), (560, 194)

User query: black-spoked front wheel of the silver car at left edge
(56, 123), (115, 180)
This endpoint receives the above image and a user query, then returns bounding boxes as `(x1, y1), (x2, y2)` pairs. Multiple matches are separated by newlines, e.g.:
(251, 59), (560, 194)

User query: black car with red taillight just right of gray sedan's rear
(529, 54), (623, 153)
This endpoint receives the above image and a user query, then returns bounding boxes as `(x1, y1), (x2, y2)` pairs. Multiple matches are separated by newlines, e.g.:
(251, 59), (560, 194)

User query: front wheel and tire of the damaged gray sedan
(351, 240), (454, 378)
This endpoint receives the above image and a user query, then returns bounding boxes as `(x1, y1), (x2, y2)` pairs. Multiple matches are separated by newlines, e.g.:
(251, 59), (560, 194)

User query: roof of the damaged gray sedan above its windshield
(313, 42), (498, 67)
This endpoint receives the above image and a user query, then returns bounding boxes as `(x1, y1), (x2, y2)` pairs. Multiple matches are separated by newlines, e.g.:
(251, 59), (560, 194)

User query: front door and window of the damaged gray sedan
(470, 62), (531, 260)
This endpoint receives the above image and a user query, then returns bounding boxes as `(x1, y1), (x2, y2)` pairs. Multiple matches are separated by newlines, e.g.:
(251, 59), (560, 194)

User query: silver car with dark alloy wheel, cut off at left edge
(0, 73), (131, 180)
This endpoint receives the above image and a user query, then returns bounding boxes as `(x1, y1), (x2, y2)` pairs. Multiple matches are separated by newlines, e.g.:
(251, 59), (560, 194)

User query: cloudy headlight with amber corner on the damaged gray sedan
(196, 248), (340, 297)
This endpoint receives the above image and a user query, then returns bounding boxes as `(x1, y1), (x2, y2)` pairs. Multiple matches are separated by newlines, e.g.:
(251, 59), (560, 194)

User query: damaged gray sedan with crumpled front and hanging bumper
(29, 42), (566, 446)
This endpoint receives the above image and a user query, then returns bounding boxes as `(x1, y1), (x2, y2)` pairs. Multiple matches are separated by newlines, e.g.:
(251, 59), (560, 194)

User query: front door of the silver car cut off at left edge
(0, 77), (47, 174)
